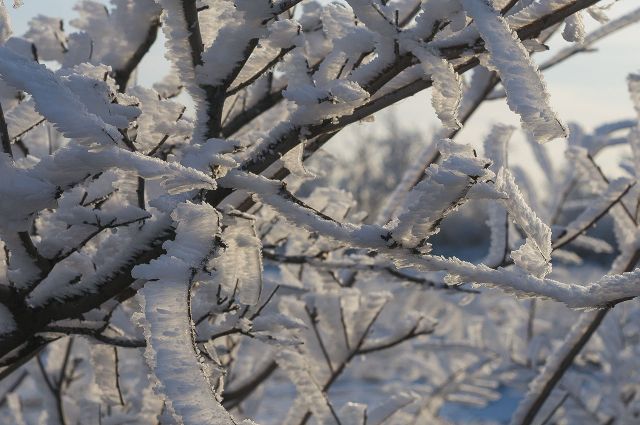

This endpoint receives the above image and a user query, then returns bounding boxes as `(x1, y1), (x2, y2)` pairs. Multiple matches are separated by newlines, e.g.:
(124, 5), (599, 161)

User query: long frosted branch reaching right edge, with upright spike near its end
(219, 167), (640, 308)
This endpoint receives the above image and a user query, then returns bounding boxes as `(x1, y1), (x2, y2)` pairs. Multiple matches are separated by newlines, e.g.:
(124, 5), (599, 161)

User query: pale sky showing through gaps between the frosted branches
(7, 0), (640, 176)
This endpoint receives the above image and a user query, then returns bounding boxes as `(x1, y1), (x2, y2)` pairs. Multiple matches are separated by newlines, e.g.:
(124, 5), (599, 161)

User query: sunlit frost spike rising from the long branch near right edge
(496, 168), (551, 277)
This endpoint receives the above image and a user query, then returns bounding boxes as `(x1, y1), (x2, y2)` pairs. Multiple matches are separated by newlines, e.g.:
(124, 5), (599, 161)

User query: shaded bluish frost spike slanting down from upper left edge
(0, 47), (122, 144)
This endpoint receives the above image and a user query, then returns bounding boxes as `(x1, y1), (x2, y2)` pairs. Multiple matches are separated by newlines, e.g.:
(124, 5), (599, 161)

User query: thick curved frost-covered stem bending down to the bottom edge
(132, 203), (235, 425)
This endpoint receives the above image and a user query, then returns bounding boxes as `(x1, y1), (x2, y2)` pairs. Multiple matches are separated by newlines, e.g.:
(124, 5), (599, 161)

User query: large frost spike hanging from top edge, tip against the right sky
(462, 0), (568, 143)
